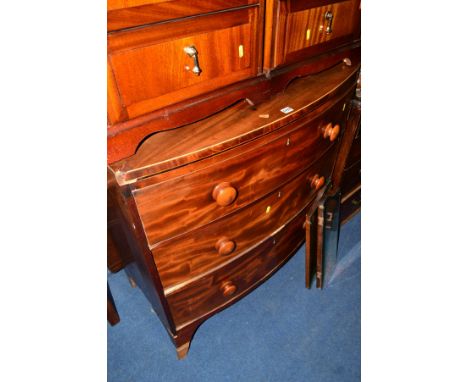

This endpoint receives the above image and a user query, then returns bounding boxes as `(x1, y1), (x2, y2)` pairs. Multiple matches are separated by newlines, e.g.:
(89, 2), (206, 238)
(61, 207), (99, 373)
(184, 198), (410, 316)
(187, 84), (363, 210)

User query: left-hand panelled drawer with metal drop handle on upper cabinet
(108, 6), (260, 124)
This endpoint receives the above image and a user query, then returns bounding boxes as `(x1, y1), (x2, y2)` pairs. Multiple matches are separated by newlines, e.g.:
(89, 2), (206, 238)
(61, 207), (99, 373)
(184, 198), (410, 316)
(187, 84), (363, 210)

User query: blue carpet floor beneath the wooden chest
(107, 214), (361, 382)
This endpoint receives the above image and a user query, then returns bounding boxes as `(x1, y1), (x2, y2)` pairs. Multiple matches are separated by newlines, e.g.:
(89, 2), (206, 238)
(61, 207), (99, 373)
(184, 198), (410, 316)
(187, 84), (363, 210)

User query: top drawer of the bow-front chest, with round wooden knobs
(134, 103), (344, 246)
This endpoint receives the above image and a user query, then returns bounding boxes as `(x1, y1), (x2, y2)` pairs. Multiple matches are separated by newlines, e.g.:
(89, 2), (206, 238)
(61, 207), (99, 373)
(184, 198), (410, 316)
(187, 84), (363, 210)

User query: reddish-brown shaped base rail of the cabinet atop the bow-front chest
(107, 44), (360, 164)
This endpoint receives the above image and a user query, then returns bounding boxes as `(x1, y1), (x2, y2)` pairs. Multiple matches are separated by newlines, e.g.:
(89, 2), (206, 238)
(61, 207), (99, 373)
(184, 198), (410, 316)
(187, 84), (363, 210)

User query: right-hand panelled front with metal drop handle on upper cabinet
(265, 0), (360, 68)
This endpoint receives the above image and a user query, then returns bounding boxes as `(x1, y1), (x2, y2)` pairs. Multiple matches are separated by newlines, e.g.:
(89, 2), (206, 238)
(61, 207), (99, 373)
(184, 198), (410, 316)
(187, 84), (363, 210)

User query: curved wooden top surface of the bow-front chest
(110, 60), (358, 184)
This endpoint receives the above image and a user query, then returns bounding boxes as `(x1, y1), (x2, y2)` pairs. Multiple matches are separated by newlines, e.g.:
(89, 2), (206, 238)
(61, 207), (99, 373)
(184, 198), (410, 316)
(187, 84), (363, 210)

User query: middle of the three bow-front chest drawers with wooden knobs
(153, 151), (335, 292)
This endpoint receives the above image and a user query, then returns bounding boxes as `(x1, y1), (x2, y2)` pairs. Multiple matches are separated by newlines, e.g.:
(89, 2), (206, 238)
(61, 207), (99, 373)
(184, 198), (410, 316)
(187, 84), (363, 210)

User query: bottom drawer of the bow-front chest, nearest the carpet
(167, 200), (305, 329)
